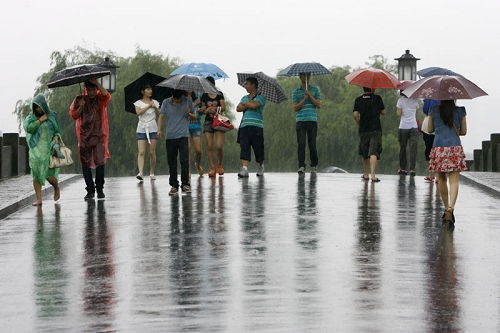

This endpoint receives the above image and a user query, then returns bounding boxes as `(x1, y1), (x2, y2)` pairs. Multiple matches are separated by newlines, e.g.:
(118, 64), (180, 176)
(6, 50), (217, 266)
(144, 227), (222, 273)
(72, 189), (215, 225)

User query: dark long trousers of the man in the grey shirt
(166, 138), (189, 187)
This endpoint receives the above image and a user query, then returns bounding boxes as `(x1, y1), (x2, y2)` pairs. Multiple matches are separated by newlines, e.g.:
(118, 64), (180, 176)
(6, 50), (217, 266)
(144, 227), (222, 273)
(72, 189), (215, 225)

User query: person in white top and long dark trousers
(396, 91), (418, 176)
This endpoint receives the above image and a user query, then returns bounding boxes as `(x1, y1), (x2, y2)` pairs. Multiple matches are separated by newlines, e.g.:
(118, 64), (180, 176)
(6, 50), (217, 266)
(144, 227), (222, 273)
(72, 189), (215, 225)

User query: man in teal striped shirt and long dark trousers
(292, 73), (321, 174)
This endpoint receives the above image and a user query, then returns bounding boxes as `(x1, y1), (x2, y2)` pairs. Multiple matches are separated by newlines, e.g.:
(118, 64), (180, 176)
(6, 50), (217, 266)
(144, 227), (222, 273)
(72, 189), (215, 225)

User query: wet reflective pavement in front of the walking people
(0, 173), (500, 332)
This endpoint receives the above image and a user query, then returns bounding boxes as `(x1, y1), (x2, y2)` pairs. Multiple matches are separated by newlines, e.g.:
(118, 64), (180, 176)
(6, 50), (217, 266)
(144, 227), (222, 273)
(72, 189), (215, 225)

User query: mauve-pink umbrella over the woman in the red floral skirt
(405, 75), (488, 101)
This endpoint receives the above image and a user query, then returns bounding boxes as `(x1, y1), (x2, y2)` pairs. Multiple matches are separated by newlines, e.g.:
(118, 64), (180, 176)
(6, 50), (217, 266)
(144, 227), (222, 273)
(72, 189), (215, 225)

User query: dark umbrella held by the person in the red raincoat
(47, 64), (111, 88)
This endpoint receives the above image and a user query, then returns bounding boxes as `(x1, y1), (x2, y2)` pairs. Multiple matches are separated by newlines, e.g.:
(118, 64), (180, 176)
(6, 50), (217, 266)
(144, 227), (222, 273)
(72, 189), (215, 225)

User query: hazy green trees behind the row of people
(14, 47), (427, 176)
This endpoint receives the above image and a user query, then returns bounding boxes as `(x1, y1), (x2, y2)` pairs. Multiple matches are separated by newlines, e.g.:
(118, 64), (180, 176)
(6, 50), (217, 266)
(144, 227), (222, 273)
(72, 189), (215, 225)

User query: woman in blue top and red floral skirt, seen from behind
(428, 100), (467, 223)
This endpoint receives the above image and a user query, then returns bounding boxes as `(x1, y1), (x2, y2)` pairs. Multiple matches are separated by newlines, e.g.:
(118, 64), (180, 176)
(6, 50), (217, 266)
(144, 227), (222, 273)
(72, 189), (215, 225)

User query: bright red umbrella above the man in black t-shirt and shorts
(345, 68), (399, 89)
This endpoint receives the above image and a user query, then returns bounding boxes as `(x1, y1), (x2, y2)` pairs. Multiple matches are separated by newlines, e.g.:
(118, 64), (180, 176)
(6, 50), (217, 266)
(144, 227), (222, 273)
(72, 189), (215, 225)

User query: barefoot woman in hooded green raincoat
(24, 94), (61, 206)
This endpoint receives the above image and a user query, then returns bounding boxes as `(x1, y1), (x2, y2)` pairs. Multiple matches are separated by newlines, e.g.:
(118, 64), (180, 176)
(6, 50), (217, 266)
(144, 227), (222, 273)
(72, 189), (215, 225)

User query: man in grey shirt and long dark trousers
(157, 89), (197, 195)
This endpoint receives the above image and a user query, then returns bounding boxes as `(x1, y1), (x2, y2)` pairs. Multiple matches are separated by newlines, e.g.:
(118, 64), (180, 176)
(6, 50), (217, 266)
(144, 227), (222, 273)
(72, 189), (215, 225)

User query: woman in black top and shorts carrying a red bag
(200, 76), (226, 177)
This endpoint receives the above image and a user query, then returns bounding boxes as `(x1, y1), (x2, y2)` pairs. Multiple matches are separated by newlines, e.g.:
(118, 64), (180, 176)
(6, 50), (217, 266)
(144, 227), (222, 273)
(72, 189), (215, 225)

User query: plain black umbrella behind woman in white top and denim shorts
(124, 72), (172, 114)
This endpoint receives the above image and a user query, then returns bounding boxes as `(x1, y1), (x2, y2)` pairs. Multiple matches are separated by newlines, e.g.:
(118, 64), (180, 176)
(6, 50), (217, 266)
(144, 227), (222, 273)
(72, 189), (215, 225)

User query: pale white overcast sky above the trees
(0, 0), (500, 153)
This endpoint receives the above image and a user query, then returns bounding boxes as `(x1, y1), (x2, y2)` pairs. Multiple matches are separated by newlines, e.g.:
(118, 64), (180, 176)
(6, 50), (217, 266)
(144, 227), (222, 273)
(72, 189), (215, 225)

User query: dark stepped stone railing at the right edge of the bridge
(467, 133), (500, 172)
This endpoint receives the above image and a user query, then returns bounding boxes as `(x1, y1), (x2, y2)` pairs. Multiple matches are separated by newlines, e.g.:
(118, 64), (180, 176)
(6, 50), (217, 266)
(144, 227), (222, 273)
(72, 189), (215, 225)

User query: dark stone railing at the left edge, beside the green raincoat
(0, 133), (30, 178)
